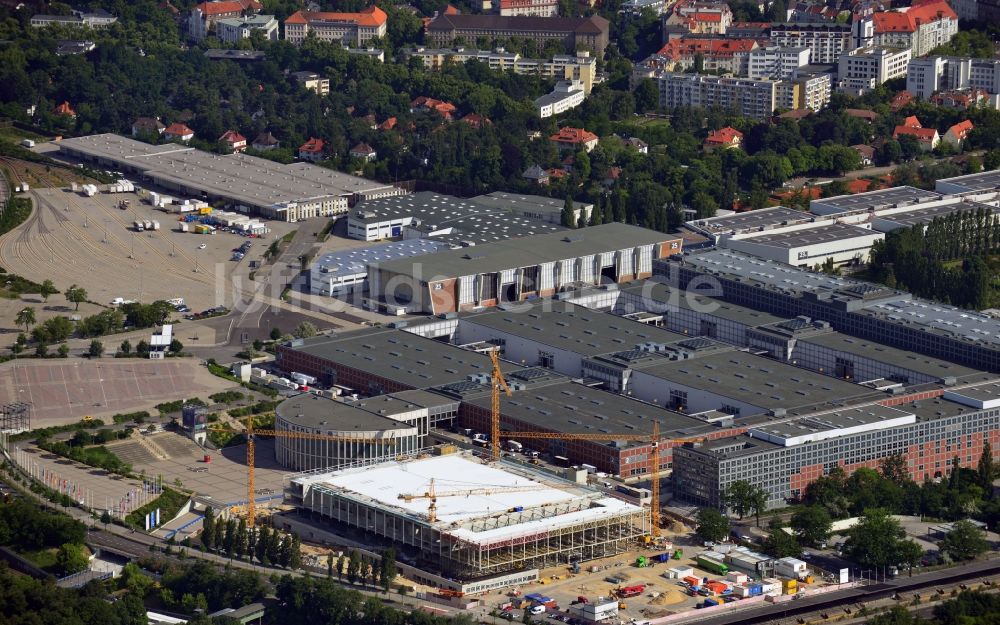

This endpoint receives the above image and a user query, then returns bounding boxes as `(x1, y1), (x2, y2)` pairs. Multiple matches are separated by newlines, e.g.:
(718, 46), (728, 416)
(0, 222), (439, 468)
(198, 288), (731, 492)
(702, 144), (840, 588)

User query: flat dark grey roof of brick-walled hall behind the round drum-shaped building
(282, 328), (520, 389)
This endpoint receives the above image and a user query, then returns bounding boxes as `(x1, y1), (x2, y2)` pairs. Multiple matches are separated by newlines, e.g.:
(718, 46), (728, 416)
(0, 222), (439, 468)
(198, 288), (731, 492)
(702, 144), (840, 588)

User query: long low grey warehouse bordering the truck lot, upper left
(59, 134), (405, 221)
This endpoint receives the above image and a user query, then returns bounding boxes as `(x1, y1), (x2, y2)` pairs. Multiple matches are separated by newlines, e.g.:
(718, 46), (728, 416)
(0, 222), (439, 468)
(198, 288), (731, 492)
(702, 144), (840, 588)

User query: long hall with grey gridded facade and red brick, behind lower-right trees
(672, 390), (1000, 508)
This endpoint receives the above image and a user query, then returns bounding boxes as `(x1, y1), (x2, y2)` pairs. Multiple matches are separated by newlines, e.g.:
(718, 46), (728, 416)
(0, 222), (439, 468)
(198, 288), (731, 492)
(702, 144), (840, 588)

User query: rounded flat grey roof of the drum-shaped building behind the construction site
(275, 393), (413, 432)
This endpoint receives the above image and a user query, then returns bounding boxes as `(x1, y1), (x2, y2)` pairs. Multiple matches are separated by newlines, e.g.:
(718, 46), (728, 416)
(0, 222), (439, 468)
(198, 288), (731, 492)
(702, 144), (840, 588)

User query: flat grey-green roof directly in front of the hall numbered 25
(459, 300), (685, 356)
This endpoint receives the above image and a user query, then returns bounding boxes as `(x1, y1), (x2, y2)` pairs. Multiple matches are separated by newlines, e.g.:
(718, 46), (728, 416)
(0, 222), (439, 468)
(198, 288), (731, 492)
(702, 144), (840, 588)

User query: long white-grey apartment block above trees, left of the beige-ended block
(655, 72), (778, 119)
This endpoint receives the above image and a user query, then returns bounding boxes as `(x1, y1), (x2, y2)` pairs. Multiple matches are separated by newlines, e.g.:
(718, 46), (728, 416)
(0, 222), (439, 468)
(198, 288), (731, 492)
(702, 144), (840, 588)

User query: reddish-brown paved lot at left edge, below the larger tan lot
(0, 358), (233, 429)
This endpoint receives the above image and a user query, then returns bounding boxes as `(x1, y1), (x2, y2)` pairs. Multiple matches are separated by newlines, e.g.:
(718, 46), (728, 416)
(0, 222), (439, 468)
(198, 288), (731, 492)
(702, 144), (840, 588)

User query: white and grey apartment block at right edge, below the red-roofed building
(906, 56), (1000, 100)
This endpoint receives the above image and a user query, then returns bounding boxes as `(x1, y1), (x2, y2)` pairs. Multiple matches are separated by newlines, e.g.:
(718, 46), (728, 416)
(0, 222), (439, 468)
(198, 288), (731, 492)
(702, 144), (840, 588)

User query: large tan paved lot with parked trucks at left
(0, 188), (295, 311)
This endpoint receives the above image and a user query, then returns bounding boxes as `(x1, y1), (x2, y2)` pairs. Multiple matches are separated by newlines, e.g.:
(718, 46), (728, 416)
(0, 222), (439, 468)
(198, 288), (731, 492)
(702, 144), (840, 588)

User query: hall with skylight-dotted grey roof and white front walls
(347, 191), (563, 247)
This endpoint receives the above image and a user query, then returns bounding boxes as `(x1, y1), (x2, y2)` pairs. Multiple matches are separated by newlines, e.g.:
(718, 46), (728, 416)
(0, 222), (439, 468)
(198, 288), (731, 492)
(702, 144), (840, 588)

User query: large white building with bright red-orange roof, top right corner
(871, 0), (958, 57)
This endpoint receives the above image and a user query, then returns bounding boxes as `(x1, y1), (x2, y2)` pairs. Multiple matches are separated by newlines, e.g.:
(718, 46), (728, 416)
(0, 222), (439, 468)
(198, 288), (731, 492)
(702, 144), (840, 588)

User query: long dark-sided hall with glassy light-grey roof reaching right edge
(655, 250), (1000, 371)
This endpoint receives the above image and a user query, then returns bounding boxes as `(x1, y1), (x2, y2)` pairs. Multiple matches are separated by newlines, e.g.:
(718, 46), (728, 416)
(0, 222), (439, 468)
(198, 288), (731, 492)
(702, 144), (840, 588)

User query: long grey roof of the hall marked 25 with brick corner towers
(372, 223), (674, 281)
